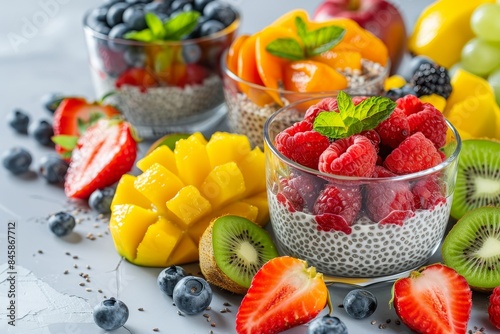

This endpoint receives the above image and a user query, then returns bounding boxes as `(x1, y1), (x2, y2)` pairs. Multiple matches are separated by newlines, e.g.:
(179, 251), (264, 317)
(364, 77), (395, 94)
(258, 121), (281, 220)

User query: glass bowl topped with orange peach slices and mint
(222, 9), (390, 147)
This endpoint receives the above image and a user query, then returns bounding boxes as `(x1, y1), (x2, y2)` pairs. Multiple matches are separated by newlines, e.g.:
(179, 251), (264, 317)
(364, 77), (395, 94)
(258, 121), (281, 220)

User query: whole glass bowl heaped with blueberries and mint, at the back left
(84, 0), (240, 139)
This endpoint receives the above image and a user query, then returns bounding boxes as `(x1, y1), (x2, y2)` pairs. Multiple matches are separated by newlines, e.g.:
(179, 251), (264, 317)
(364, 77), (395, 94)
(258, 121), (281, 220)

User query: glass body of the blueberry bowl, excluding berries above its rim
(84, 12), (240, 139)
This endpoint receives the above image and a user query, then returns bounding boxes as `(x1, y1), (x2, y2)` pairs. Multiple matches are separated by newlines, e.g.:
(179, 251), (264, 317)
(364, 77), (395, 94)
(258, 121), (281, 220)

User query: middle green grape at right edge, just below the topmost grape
(461, 38), (500, 77)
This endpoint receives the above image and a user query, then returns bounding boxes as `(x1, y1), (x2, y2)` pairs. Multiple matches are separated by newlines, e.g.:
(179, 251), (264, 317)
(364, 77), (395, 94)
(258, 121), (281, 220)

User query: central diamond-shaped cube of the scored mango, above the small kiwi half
(167, 185), (212, 226)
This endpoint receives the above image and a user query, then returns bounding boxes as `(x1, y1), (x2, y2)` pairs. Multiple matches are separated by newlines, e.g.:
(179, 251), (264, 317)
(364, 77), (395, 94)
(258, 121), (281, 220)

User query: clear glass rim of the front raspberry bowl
(263, 97), (462, 183)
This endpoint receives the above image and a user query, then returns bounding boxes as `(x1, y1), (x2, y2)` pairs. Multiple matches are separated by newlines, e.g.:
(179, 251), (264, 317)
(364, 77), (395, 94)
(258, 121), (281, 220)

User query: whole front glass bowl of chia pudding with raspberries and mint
(264, 92), (461, 283)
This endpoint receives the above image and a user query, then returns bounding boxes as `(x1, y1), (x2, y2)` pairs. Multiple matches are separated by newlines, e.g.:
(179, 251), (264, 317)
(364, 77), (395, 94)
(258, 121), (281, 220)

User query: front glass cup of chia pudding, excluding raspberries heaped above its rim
(264, 98), (461, 283)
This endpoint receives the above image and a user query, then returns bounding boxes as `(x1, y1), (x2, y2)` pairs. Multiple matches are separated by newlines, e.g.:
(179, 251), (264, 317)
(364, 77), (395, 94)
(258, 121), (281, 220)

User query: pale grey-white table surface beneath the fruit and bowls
(0, 0), (498, 334)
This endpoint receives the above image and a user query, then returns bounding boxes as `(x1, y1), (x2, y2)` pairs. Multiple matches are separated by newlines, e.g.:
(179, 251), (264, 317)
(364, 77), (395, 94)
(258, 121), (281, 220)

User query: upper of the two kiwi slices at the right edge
(451, 139), (500, 219)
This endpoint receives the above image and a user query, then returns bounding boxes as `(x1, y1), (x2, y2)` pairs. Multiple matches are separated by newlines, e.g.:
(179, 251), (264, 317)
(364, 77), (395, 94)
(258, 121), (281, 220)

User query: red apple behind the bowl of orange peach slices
(313, 0), (407, 73)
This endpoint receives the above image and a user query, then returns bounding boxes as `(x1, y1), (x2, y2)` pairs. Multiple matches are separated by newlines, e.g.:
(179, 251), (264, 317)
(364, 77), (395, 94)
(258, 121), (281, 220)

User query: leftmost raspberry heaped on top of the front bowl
(275, 121), (330, 169)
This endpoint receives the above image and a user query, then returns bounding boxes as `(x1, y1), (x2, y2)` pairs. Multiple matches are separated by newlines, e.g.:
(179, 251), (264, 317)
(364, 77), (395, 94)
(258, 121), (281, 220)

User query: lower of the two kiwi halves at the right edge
(441, 207), (500, 291)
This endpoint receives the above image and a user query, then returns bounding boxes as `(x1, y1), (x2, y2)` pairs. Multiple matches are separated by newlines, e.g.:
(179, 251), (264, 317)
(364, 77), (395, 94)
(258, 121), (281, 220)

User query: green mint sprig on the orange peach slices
(266, 17), (345, 60)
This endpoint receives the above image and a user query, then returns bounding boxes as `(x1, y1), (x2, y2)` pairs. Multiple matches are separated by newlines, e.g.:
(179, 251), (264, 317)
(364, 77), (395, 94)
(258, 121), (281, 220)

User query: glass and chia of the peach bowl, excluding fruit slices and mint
(222, 54), (390, 148)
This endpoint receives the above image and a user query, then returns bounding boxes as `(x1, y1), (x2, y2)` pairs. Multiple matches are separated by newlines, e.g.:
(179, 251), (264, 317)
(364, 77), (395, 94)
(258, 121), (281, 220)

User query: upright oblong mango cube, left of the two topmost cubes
(174, 134), (210, 186)
